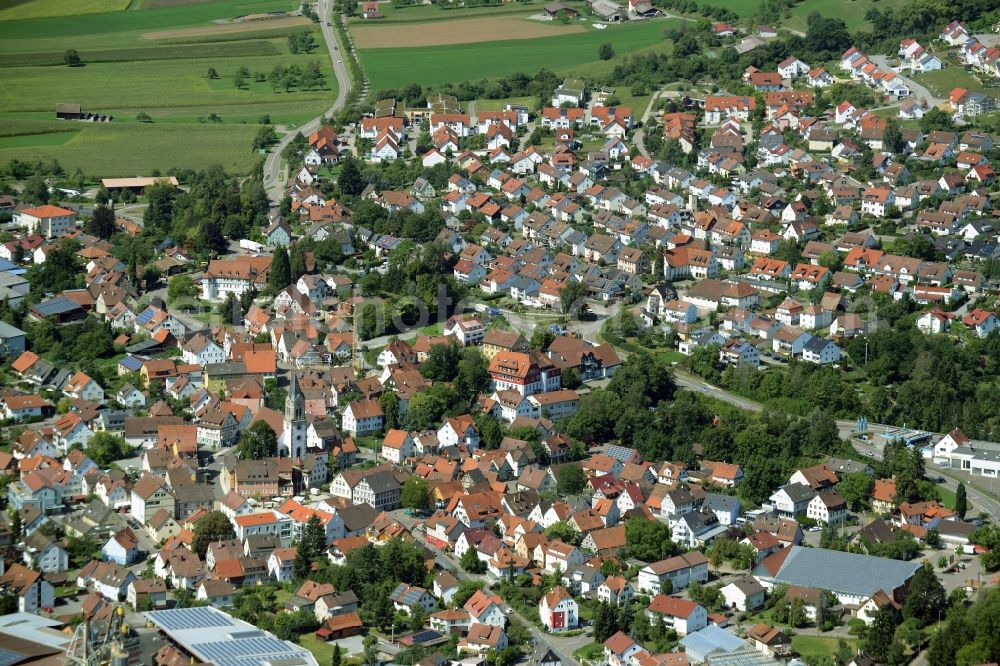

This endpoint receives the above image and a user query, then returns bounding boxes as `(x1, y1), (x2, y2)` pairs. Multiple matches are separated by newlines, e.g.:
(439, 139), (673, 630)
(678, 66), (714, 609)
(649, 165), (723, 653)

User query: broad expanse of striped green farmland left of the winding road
(0, 0), (336, 177)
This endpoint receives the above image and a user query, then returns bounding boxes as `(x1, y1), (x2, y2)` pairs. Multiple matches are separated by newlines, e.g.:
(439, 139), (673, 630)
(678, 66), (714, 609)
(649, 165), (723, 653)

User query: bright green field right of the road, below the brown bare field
(359, 20), (676, 91)
